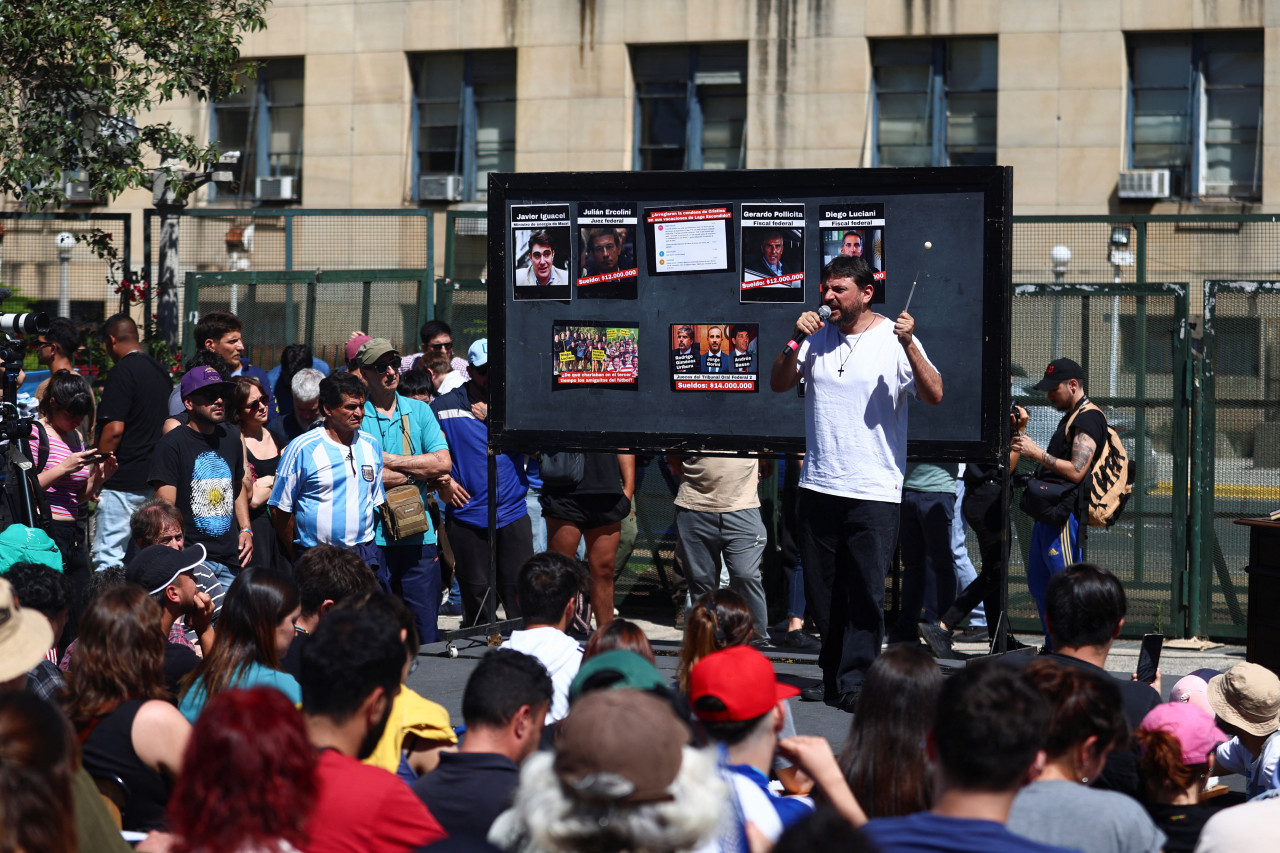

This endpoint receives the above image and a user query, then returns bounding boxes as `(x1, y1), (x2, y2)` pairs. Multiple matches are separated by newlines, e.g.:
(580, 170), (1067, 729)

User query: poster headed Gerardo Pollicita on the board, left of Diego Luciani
(741, 204), (804, 302)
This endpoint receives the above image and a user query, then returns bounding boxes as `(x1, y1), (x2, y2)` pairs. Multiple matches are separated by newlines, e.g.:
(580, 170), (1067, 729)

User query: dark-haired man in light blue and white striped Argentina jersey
(268, 371), (385, 573)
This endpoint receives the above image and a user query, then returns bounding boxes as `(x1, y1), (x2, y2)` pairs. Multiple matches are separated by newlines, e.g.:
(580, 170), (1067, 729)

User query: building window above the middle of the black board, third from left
(631, 44), (746, 172)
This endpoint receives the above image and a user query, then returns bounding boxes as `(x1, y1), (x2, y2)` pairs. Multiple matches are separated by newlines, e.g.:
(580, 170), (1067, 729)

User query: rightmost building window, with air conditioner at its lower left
(1128, 32), (1262, 199)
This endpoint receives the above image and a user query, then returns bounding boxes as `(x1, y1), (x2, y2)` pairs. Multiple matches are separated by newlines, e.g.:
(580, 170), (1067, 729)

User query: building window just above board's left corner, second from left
(411, 50), (516, 201)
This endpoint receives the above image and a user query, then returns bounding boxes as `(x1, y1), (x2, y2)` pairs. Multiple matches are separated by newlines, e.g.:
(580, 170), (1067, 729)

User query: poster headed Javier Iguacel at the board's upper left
(511, 205), (573, 301)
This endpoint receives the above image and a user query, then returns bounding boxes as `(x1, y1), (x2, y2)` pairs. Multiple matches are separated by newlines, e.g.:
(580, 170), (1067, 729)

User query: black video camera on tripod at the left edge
(0, 287), (49, 526)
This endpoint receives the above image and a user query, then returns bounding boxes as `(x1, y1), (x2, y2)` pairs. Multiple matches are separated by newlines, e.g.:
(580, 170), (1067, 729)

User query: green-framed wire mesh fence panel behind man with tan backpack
(1009, 283), (1187, 634)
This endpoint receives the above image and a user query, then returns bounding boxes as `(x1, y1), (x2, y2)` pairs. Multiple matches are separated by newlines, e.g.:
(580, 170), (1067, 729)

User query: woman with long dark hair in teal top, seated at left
(178, 566), (302, 722)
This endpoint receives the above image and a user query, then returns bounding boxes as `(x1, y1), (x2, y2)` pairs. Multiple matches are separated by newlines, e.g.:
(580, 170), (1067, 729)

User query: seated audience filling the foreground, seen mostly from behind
(0, 537), (1280, 853)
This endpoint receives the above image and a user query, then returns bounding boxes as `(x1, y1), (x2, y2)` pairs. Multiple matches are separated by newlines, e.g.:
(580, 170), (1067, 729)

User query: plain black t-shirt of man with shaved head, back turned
(97, 352), (173, 492)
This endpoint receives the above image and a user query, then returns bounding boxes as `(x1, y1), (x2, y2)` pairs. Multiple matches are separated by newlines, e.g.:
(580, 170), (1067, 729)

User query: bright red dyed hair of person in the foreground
(169, 688), (316, 853)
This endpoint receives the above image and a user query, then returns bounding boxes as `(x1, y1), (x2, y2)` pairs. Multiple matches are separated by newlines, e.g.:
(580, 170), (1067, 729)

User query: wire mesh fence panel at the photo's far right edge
(1199, 280), (1280, 637)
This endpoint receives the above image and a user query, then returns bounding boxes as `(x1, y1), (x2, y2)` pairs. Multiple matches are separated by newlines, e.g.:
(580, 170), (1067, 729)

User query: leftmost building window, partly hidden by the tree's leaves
(209, 59), (303, 201)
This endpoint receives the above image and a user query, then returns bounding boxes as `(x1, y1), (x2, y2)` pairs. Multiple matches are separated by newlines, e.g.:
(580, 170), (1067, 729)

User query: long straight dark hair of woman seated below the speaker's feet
(840, 643), (942, 817)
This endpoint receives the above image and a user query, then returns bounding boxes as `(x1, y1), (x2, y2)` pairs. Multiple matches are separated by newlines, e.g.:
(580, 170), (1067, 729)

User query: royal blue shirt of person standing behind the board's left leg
(431, 383), (529, 528)
